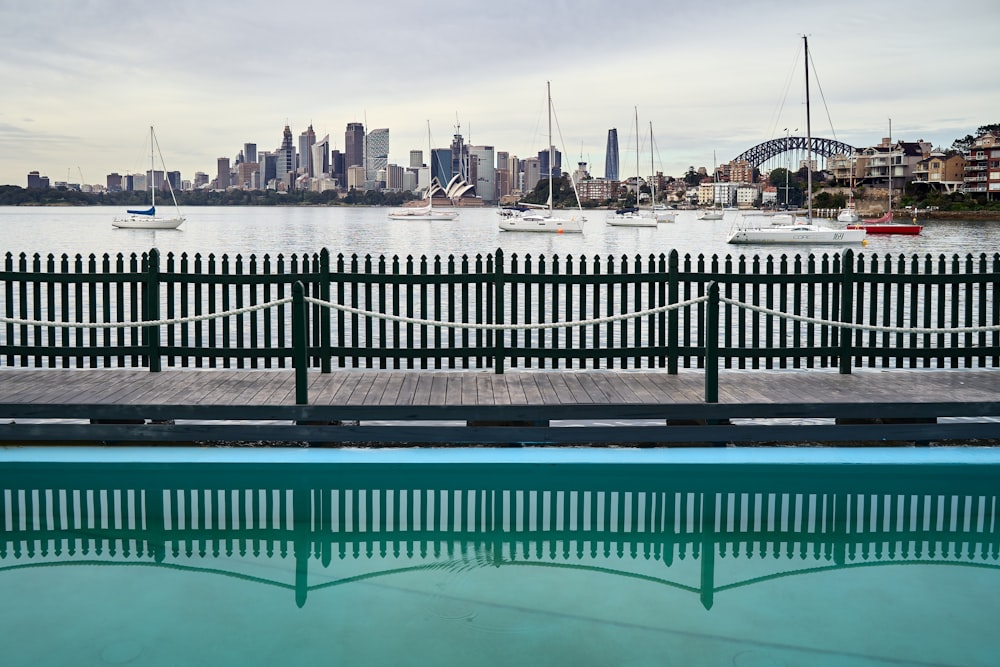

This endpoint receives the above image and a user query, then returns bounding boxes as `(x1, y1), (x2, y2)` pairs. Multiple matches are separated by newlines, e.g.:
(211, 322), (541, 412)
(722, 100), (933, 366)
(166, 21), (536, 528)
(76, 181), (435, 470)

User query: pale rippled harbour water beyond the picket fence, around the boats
(0, 207), (1000, 259)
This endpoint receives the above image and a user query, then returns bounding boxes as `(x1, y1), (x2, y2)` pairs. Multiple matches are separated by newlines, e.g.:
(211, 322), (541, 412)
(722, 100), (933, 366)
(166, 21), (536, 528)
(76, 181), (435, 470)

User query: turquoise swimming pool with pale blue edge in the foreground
(0, 448), (1000, 667)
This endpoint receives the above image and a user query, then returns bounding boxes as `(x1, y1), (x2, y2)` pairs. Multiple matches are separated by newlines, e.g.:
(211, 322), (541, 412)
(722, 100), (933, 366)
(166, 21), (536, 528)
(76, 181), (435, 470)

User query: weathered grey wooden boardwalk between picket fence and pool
(0, 369), (1000, 444)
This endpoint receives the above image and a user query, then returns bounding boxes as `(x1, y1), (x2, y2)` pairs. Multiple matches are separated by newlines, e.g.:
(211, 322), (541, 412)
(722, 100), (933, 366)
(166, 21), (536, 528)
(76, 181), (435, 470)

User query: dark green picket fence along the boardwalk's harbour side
(0, 249), (1000, 386)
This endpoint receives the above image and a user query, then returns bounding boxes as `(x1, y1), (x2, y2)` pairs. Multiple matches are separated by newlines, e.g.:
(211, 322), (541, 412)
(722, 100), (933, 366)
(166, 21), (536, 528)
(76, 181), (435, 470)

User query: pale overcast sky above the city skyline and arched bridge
(0, 0), (1000, 187)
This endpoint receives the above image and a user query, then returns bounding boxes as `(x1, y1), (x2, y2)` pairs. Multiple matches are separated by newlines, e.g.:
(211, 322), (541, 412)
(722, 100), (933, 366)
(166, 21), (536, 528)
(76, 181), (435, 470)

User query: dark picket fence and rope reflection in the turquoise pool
(0, 464), (1000, 607)
